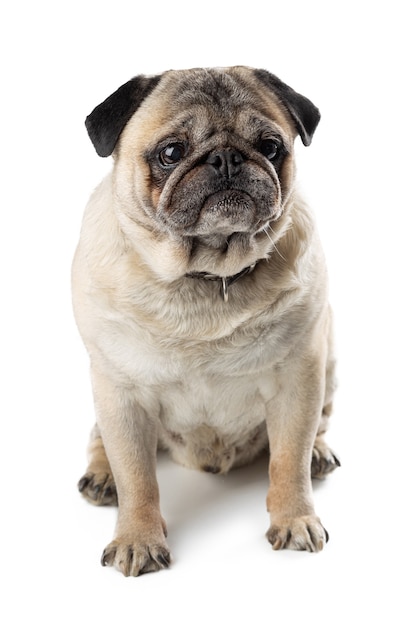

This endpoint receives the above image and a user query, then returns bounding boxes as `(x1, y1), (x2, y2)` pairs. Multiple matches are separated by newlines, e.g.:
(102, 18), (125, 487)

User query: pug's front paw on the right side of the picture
(266, 515), (329, 552)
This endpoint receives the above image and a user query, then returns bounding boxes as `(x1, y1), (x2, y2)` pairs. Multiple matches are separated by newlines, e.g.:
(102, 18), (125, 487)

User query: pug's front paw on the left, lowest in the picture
(101, 538), (171, 576)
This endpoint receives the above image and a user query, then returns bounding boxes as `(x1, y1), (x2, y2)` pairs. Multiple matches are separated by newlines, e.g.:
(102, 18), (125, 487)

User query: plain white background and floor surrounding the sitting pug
(0, 0), (417, 626)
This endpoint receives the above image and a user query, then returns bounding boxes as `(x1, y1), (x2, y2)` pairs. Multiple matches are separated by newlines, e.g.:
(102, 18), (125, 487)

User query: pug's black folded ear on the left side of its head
(85, 75), (161, 157)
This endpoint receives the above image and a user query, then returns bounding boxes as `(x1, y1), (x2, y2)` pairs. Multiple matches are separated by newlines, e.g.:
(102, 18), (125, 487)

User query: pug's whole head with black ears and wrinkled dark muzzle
(87, 67), (319, 274)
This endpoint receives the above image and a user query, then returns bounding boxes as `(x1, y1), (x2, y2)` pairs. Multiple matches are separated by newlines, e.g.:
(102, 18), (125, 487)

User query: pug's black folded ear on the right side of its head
(255, 70), (320, 146)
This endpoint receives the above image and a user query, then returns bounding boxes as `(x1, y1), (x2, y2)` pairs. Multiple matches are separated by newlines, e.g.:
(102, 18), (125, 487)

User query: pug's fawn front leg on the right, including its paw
(267, 355), (328, 552)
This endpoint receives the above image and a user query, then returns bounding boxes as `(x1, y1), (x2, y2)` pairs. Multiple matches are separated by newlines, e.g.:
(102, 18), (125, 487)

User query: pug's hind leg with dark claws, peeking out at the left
(78, 424), (117, 506)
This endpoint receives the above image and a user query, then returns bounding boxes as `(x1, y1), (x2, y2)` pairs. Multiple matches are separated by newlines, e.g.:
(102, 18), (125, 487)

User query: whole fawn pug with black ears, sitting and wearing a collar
(72, 66), (339, 576)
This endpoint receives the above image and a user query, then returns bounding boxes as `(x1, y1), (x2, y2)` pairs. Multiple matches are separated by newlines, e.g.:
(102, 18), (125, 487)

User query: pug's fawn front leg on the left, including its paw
(92, 368), (170, 576)
